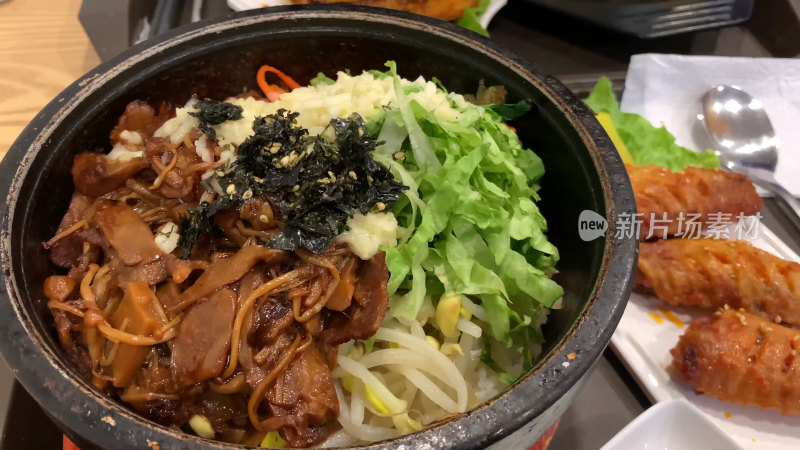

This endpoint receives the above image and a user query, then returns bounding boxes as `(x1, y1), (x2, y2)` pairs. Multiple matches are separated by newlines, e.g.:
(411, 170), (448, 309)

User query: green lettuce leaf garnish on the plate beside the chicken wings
(585, 77), (720, 171)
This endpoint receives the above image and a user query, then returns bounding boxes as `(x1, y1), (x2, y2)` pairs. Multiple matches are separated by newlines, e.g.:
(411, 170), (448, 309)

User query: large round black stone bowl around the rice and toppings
(0, 6), (637, 449)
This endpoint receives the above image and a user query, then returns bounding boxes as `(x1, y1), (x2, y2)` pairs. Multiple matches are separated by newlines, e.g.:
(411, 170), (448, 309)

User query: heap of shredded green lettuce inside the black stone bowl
(374, 62), (563, 361)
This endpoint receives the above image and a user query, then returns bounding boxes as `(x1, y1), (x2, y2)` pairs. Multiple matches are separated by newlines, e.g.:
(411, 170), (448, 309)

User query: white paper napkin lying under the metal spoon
(620, 54), (800, 196)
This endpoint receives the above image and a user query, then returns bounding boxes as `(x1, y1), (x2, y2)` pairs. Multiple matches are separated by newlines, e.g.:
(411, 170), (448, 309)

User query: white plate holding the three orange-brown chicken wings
(611, 224), (800, 450)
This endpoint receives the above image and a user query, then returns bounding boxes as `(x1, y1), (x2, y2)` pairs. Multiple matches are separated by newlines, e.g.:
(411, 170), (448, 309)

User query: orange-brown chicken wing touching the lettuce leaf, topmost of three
(626, 165), (763, 240)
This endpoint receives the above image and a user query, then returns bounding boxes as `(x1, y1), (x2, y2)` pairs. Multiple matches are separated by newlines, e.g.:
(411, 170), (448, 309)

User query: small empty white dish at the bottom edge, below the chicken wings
(600, 400), (739, 450)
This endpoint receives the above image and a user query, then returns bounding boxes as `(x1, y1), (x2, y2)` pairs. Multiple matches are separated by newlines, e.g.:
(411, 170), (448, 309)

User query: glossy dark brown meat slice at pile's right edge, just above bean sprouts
(320, 252), (389, 346)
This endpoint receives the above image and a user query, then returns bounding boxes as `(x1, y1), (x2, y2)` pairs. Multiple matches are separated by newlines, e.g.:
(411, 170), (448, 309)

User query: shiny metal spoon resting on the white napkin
(698, 85), (800, 226)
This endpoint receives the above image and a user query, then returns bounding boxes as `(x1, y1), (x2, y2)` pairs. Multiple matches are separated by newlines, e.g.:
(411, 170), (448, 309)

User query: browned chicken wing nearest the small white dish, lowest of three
(670, 310), (800, 415)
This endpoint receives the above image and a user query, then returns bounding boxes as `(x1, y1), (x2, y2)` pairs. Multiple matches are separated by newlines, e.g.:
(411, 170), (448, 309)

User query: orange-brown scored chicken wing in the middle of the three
(636, 239), (800, 326)
